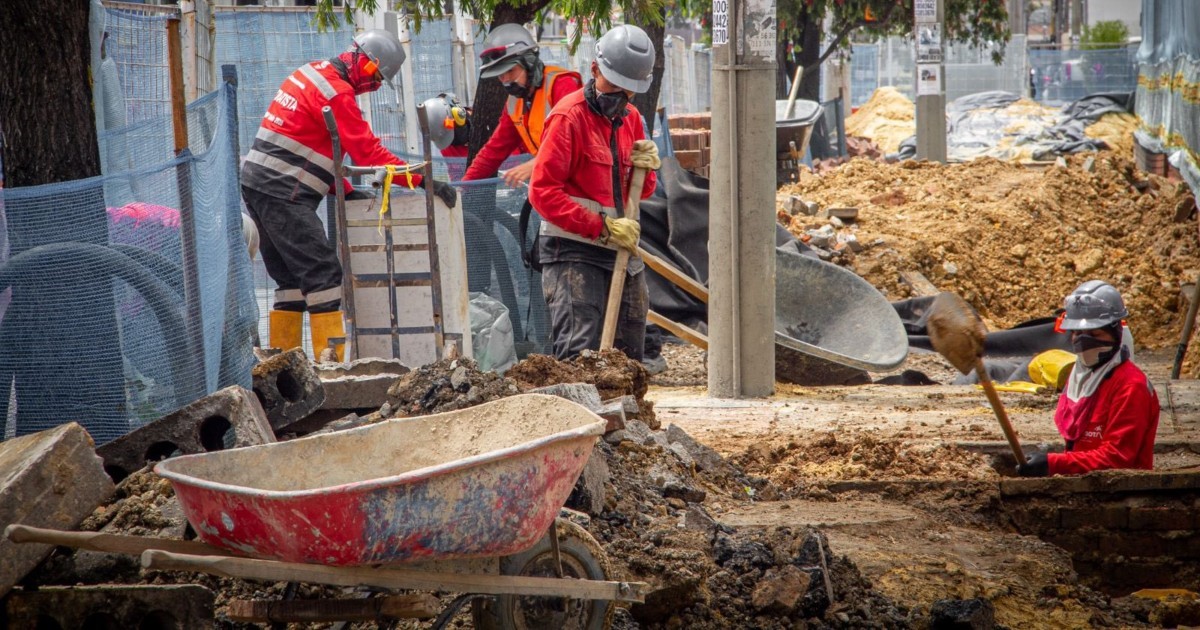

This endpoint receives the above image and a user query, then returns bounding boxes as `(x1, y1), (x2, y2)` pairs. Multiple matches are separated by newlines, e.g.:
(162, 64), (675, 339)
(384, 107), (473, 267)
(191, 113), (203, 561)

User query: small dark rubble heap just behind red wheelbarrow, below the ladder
(379, 359), (520, 418)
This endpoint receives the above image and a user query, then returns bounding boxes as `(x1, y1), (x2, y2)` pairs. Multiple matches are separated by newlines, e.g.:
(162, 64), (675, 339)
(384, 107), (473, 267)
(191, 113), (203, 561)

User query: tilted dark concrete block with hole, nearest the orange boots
(253, 348), (325, 434)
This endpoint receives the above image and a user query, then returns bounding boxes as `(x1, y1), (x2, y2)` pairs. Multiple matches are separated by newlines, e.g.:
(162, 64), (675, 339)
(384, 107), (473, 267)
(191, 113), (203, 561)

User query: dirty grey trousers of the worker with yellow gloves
(541, 262), (649, 361)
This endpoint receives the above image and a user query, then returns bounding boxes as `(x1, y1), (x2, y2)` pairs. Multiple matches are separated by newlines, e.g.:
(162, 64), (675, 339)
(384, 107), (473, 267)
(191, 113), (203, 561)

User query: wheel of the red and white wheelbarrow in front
(472, 518), (613, 630)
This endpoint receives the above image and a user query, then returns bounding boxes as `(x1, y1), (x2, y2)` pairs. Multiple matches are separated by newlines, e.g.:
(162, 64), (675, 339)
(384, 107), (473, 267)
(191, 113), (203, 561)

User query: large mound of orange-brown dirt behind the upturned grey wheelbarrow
(778, 151), (1200, 348)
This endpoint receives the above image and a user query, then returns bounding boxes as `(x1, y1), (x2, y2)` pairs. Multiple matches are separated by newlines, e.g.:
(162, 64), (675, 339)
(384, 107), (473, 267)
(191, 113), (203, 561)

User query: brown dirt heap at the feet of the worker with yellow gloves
(504, 350), (658, 426)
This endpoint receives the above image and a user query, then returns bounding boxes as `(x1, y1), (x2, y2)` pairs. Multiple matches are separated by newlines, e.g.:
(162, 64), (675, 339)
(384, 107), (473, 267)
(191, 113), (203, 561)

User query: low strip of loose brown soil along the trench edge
(733, 432), (1000, 488)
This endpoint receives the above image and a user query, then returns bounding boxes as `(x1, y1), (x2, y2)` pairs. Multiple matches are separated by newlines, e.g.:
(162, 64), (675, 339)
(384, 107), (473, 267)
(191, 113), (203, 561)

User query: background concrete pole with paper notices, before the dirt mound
(913, 0), (946, 163)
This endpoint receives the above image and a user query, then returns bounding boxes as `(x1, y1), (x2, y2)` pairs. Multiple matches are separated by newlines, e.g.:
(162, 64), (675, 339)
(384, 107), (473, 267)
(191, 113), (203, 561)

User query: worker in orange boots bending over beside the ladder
(241, 30), (456, 360)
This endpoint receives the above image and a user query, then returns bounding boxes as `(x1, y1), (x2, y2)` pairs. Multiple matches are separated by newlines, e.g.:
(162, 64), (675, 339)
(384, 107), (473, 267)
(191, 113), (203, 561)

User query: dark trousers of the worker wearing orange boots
(241, 186), (342, 313)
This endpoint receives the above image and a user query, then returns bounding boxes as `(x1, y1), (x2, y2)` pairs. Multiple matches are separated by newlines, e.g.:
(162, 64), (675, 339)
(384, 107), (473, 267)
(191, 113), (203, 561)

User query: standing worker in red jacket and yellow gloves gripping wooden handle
(529, 24), (660, 361)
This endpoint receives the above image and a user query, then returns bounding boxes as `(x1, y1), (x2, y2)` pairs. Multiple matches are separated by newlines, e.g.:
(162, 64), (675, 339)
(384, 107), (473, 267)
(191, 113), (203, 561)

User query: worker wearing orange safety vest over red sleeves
(463, 24), (583, 187)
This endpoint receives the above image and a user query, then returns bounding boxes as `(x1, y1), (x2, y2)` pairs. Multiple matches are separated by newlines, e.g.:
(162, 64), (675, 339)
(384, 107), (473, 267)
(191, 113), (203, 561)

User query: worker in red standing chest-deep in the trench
(1016, 280), (1159, 476)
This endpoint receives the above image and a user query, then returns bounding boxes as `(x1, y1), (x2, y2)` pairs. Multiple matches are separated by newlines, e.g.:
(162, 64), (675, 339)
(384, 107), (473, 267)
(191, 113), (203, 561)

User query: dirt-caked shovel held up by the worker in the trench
(929, 292), (1025, 464)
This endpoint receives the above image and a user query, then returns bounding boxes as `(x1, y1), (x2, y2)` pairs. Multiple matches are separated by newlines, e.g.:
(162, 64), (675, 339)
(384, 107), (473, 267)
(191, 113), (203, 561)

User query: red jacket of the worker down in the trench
(1048, 361), (1159, 475)
